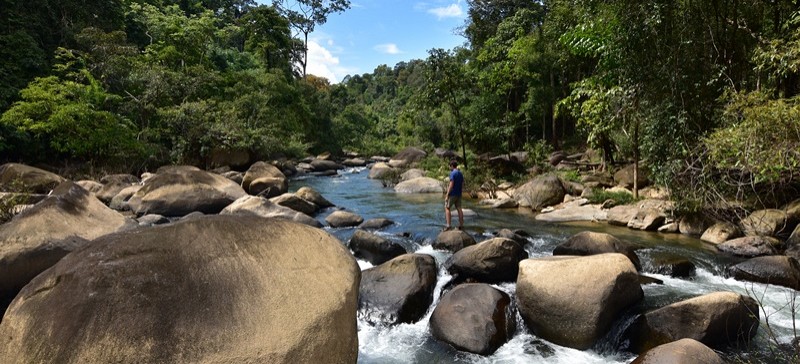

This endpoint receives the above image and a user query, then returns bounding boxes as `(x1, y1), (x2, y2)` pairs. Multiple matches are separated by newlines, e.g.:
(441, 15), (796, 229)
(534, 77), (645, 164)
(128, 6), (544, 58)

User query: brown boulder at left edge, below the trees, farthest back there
(0, 163), (66, 193)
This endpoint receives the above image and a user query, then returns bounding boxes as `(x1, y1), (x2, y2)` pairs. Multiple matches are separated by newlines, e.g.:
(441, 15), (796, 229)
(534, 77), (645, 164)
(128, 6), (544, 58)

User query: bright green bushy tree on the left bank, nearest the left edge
(0, 49), (141, 161)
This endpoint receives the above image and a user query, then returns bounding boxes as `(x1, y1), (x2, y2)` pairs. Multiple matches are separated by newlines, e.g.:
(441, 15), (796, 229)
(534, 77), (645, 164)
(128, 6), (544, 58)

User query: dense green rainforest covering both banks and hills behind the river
(0, 0), (800, 212)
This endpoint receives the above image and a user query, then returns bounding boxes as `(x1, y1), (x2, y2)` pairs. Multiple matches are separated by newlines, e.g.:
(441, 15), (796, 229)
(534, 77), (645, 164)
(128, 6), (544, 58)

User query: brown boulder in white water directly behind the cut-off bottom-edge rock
(626, 292), (759, 352)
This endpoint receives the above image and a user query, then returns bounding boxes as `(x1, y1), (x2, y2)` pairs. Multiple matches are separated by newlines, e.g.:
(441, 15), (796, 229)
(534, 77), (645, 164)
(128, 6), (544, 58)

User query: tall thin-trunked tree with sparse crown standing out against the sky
(272, 0), (350, 78)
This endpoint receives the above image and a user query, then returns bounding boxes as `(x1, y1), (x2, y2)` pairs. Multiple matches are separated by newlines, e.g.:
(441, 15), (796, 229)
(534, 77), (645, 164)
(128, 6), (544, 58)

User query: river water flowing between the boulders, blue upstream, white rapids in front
(290, 168), (800, 363)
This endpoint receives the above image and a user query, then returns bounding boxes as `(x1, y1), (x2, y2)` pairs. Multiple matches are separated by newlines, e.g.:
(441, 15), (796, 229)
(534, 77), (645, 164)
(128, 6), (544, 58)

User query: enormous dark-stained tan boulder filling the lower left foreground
(0, 216), (360, 363)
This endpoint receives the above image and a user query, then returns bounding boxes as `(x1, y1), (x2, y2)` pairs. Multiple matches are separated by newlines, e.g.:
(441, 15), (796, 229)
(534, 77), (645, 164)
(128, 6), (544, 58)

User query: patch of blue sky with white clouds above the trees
(260, 0), (467, 83)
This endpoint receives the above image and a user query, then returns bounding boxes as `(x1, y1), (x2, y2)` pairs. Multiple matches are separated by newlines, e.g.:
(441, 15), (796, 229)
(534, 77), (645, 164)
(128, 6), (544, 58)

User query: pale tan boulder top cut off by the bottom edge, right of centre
(631, 339), (725, 364)
